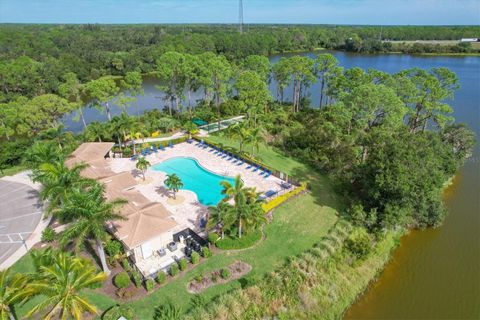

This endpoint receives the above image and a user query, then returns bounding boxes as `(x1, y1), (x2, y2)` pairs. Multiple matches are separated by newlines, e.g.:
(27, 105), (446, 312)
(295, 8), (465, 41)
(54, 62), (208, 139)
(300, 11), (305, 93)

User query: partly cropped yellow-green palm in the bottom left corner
(0, 269), (32, 320)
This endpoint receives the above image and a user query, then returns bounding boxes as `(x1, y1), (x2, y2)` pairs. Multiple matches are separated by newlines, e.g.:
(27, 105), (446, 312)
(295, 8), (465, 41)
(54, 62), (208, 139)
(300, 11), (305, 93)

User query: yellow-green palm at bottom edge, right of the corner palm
(27, 251), (107, 320)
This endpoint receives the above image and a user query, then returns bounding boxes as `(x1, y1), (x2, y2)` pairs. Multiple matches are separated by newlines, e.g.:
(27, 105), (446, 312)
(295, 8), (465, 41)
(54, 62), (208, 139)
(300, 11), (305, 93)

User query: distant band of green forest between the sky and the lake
(0, 24), (480, 101)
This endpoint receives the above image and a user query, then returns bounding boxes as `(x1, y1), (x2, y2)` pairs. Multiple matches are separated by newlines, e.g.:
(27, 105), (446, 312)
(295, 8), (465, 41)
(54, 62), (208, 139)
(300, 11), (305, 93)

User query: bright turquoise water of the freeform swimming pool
(152, 157), (235, 206)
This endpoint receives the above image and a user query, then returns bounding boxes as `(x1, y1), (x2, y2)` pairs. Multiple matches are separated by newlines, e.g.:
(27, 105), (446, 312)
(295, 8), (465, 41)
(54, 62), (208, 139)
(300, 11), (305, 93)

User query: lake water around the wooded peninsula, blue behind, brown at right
(66, 52), (480, 319)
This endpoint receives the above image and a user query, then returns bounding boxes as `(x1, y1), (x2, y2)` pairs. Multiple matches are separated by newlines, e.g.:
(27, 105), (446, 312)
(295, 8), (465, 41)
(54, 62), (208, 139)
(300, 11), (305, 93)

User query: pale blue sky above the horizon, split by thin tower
(0, 0), (480, 25)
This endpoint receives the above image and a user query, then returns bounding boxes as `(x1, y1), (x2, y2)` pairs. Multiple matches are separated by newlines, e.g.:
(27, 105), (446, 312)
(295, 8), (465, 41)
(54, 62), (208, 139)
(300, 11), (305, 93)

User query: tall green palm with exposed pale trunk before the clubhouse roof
(59, 183), (127, 274)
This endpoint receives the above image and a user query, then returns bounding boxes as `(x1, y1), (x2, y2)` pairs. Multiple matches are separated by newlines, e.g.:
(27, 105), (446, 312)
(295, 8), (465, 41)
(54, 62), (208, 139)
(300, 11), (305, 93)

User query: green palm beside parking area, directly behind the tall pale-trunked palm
(32, 160), (94, 213)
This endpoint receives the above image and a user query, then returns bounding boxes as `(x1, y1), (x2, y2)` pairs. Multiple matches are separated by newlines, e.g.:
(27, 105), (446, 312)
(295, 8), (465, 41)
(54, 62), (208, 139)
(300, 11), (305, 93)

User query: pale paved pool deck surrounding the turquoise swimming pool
(110, 142), (283, 231)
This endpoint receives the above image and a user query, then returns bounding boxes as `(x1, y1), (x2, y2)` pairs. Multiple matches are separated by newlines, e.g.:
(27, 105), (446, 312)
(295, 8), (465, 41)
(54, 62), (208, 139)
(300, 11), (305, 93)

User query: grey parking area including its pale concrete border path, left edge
(0, 171), (49, 270)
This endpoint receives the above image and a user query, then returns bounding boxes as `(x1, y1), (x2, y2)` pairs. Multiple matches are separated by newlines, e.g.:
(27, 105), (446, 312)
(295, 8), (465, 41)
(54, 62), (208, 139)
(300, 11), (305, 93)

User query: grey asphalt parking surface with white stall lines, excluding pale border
(0, 179), (42, 265)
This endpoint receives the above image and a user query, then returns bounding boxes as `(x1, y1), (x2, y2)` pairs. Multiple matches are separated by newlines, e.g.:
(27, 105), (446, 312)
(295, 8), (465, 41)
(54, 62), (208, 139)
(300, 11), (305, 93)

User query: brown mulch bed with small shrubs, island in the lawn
(187, 261), (252, 293)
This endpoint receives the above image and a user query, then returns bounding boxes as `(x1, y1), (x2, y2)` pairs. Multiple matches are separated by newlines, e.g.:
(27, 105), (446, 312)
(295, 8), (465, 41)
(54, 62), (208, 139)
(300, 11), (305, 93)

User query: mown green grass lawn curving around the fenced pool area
(11, 136), (341, 319)
